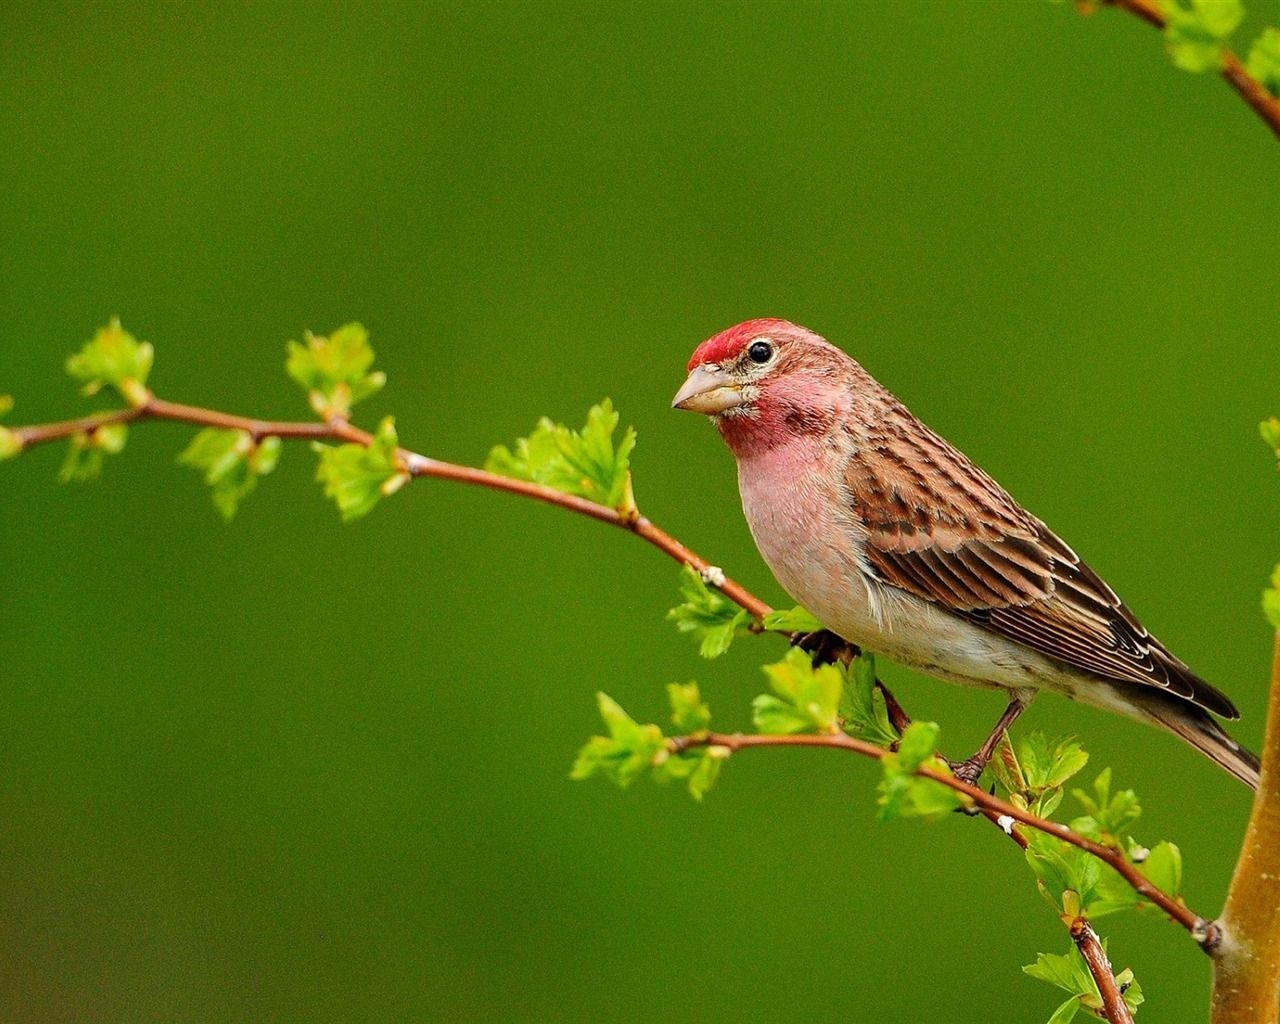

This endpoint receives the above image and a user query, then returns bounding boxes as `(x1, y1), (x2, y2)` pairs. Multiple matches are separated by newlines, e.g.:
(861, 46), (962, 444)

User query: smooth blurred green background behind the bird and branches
(0, 3), (1280, 1024)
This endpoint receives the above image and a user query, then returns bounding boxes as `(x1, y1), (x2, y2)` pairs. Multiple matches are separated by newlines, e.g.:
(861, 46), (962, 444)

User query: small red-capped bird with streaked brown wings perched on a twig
(672, 319), (1258, 788)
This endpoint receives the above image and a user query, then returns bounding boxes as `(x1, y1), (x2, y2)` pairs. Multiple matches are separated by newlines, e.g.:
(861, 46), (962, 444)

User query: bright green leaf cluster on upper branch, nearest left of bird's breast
(485, 398), (636, 513)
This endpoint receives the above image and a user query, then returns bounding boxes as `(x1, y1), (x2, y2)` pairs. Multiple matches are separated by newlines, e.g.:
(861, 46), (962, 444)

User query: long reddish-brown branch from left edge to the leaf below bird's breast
(10, 392), (772, 626)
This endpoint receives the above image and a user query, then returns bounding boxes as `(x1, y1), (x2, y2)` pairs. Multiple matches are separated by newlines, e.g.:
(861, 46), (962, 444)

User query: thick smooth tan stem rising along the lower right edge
(1210, 631), (1280, 1024)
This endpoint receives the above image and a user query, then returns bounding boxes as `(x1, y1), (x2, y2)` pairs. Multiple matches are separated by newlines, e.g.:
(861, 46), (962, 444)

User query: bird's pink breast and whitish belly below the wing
(739, 442), (1066, 690)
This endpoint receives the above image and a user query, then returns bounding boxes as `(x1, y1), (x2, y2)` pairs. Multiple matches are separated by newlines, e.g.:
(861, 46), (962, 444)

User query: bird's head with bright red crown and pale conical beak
(671, 317), (858, 454)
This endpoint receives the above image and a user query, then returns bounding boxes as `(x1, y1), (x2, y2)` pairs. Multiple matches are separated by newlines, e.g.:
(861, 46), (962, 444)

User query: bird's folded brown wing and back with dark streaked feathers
(845, 398), (1239, 718)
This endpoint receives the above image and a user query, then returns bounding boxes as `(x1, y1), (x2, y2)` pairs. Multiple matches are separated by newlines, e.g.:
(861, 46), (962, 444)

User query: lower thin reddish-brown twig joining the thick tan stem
(668, 732), (1213, 952)
